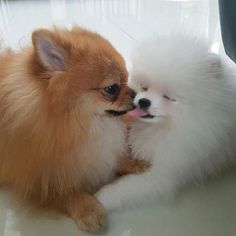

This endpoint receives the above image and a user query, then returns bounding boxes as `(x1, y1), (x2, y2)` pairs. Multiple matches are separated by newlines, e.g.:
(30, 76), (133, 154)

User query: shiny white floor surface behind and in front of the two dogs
(0, 0), (236, 236)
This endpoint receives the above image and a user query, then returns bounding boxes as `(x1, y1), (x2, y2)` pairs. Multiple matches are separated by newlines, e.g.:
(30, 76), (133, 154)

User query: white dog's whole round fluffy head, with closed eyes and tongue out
(126, 36), (221, 122)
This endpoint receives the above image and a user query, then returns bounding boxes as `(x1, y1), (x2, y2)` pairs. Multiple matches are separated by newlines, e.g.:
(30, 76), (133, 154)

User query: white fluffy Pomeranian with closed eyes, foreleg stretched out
(97, 35), (236, 211)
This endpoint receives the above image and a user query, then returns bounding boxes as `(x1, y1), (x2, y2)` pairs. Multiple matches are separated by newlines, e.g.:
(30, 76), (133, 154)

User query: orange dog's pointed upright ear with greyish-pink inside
(32, 30), (66, 72)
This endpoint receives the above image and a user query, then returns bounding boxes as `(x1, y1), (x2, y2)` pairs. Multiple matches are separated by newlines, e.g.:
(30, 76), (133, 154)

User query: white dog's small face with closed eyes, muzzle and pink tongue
(129, 73), (178, 123)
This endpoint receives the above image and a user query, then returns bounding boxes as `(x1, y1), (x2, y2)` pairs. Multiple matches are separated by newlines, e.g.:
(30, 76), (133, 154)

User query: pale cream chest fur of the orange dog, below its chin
(77, 118), (126, 190)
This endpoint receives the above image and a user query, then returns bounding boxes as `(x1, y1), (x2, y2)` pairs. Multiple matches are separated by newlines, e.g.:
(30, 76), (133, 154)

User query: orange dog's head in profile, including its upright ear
(31, 28), (133, 116)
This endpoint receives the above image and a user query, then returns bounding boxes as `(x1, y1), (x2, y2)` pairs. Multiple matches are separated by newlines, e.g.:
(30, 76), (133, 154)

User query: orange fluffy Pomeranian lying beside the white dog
(0, 27), (148, 232)
